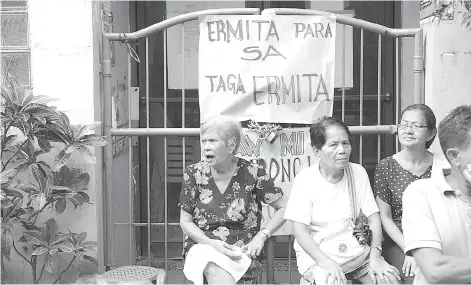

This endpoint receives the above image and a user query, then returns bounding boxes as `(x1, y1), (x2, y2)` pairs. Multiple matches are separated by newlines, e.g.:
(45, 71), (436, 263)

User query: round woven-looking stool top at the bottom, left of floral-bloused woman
(100, 265), (162, 283)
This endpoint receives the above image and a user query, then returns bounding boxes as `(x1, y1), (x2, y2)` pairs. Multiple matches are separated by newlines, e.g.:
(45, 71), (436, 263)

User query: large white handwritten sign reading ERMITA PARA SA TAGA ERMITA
(199, 15), (336, 124)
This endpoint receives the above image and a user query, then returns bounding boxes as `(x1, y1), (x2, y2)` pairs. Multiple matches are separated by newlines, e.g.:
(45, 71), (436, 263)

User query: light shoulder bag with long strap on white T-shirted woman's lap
(319, 163), (371, 273)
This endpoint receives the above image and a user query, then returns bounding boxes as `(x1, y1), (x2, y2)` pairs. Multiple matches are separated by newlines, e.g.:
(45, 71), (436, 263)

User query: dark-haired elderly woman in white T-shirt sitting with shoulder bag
(284, 118), (400, 284)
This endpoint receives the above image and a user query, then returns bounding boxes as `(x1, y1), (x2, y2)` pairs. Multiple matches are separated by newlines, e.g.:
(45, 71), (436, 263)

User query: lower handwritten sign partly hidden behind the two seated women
(237, 128), (317, 235)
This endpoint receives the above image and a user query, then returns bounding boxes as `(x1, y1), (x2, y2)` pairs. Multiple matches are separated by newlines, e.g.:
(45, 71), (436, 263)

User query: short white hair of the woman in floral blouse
(200, 115), (242, 154)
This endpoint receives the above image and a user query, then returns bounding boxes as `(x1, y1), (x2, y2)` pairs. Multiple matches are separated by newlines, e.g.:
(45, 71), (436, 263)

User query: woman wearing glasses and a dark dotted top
(373, 104), (448, 284)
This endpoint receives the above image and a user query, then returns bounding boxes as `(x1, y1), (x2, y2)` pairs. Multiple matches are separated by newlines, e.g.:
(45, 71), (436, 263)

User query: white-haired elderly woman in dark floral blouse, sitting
(179, 117), (286, 284)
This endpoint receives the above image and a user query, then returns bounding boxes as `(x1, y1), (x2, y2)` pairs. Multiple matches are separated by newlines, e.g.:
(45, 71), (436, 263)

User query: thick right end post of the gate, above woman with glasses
(414, 29), (425, 104)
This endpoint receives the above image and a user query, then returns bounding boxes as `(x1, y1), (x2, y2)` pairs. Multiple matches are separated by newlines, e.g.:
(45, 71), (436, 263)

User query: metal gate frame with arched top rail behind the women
(101, 8), (425, 284)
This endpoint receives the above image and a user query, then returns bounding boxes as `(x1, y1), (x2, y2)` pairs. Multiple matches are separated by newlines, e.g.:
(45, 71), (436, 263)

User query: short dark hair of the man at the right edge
(438, 105), (471, 158)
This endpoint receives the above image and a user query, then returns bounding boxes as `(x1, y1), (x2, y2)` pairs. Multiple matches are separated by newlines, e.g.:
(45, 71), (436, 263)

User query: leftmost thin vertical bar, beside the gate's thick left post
(126, 46), (134, 265)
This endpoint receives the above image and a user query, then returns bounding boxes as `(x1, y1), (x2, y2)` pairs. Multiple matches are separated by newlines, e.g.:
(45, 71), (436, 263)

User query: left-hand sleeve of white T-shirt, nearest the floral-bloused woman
(284, 168), (314, 226)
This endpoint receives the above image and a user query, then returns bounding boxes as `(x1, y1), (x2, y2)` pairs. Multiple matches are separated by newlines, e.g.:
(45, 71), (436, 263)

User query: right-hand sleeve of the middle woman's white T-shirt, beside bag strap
(352, 164), (379, 217)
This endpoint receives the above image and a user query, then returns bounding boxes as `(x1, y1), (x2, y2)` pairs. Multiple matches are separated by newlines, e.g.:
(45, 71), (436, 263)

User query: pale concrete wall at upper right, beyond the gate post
(421, 8), (471, 152)
